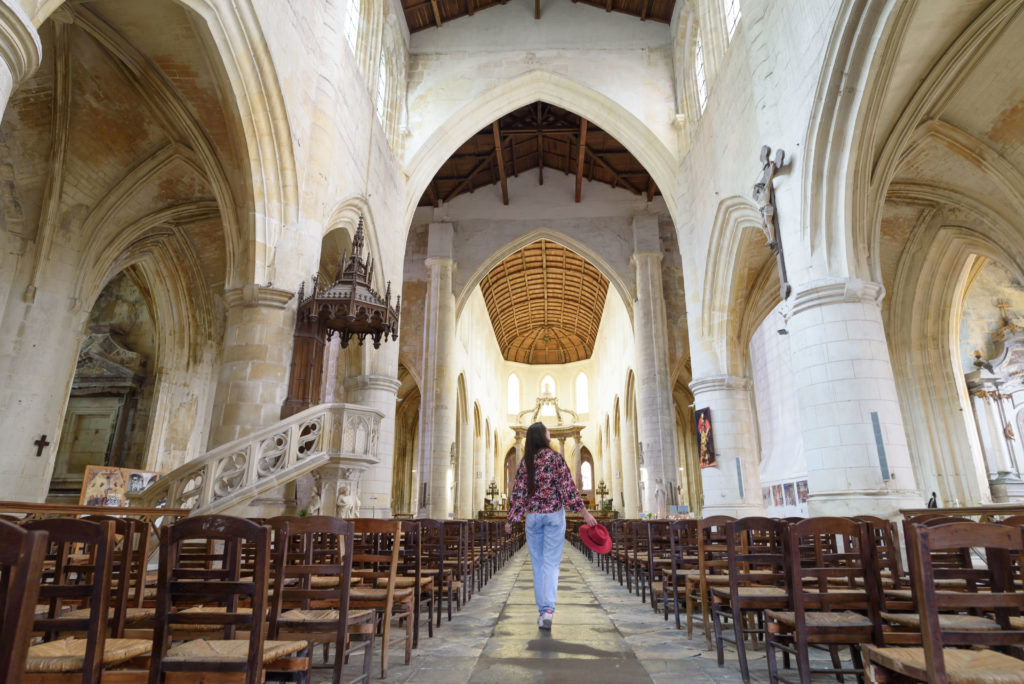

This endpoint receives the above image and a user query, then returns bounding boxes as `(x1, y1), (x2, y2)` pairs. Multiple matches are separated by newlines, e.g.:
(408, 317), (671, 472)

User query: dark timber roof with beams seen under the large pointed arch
(420, 102), (658, 207)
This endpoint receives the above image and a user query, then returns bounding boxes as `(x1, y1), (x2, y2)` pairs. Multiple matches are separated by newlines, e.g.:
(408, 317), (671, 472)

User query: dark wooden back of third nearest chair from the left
(151, 515), (270, 684)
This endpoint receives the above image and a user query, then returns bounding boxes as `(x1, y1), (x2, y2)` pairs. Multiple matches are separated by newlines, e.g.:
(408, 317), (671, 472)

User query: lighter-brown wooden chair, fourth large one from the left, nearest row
(349, 518), (416, 679)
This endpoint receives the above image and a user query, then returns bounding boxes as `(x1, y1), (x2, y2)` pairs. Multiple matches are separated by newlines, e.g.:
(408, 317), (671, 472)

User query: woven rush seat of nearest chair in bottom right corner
(866, 646), (1024, 684)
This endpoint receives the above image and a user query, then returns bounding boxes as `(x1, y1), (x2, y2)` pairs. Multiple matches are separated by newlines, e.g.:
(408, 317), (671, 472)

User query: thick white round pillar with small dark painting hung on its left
(690, 375), (765, 518)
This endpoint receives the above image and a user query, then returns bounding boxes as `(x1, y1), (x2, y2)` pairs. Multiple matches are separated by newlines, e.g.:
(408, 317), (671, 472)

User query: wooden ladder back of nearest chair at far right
(908, 521), (1024, 684)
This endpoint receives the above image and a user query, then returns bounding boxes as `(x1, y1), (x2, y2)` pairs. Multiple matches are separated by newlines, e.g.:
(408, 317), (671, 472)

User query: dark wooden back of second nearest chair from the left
(22, 518), (114, 684)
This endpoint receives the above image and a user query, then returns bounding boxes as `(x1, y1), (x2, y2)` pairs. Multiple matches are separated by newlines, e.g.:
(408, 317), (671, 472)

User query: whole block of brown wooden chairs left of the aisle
(0, 516), (522, 684)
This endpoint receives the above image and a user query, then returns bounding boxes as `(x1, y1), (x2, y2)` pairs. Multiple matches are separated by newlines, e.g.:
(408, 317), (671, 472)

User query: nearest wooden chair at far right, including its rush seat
(863, 521), (1024, 684)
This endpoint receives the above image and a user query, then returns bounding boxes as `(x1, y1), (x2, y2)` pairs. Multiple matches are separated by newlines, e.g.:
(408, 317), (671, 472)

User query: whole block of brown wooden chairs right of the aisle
(572, 516), (1024, 682)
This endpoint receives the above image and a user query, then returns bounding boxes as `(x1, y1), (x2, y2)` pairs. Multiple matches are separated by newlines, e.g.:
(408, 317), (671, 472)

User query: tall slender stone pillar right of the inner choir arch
(632, 216), (679, 511)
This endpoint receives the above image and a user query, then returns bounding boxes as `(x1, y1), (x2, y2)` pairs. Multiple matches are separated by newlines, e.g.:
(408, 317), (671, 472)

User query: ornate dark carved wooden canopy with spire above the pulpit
(296, 216), (401, 349)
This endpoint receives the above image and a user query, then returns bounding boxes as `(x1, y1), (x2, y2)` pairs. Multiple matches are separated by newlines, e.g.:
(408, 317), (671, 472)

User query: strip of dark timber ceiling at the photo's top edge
(401, 0), (676, 33)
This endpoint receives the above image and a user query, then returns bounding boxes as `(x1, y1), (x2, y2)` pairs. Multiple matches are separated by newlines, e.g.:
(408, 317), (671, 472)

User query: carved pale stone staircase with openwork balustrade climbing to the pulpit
(131, 403), (384, 516)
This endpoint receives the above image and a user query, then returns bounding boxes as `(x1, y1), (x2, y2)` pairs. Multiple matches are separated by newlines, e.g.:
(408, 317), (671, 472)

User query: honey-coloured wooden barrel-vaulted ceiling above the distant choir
(480, 240), (608, 364)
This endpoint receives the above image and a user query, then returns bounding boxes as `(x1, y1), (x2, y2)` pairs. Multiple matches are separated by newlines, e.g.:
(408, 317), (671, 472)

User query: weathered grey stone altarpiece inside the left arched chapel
(47, 324), (146, 504)
